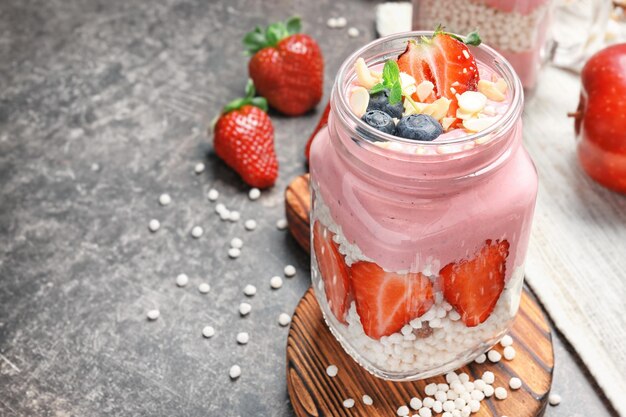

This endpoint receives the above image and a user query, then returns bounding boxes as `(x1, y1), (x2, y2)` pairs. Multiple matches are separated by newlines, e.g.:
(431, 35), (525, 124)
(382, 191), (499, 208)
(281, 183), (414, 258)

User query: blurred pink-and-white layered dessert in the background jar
(414, 0), (551, 88)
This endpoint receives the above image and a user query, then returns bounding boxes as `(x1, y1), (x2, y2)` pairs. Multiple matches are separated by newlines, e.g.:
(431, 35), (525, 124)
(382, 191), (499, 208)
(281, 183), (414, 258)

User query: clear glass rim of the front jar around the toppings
(331, 31), (524, 147)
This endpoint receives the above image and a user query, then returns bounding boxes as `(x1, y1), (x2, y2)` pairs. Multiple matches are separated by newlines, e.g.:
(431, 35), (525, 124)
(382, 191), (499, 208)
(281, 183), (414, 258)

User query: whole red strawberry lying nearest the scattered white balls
(213, 81), (278, 188)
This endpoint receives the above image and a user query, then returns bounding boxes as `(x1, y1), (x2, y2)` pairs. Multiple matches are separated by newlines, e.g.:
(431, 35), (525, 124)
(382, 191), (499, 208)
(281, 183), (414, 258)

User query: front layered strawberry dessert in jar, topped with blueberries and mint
(310, 30), (537, 379)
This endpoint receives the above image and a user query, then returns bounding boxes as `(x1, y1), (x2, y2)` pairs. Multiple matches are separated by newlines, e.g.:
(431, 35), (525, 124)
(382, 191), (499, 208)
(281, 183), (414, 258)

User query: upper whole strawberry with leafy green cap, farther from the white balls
(243, 17), (324, 116)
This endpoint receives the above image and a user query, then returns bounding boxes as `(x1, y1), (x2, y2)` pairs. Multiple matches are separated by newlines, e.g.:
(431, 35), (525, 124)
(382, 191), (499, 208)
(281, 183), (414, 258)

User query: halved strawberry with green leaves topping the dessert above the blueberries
(398, 29), (480, 117)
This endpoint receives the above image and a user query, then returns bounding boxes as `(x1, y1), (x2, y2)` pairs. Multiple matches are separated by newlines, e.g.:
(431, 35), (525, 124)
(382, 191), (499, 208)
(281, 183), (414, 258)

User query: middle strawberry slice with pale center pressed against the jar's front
(350, 262), (434, 339)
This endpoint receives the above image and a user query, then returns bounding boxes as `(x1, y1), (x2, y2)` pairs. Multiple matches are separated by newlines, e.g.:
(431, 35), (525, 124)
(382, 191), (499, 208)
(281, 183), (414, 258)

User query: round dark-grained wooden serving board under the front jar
(285, 175), (554, 417)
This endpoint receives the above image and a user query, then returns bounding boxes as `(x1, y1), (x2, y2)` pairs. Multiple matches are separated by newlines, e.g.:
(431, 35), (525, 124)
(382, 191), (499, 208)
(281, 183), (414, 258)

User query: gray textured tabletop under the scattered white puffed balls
(0, 0), (611, 417)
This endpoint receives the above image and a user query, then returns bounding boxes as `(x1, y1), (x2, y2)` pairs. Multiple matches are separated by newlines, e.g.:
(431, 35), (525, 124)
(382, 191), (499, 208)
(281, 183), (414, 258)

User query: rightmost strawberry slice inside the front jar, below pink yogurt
(439, 240), (509, 327)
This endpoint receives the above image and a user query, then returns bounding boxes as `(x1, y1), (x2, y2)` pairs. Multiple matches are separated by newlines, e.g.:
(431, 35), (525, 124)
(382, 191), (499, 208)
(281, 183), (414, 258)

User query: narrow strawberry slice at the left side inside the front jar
(313, 221), (350, 323)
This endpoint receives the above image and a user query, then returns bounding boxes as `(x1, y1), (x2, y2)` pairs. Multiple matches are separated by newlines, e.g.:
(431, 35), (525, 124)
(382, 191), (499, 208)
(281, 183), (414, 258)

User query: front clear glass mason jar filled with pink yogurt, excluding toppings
(310, 32), (537, 380)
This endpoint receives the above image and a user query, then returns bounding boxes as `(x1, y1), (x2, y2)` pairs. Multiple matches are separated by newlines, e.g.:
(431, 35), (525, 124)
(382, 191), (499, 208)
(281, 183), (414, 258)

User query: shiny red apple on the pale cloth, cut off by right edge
(575, 43), (626, 193)
